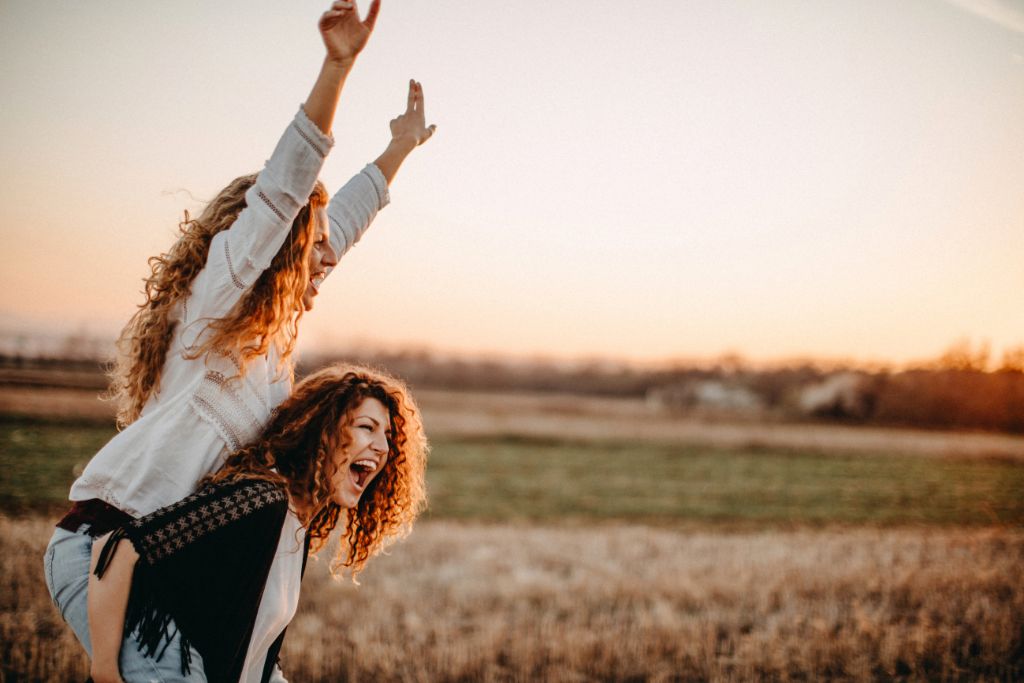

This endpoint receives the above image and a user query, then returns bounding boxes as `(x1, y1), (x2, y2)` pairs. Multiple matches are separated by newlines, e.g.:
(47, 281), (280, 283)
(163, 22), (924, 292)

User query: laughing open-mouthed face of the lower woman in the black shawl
(331, 398), (391, 508)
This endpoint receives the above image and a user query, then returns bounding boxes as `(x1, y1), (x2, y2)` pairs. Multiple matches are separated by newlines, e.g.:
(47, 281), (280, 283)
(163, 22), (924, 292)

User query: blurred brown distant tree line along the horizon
(0, 335), (1024, 433)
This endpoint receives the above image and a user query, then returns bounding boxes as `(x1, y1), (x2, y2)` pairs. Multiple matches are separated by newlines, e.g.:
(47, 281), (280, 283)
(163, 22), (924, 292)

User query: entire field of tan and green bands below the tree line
(0, 378), (1024, 682)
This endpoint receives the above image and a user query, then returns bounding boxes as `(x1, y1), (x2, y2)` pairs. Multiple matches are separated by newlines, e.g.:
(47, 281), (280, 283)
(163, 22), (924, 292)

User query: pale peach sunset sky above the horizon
(0, 0), (1024, 362)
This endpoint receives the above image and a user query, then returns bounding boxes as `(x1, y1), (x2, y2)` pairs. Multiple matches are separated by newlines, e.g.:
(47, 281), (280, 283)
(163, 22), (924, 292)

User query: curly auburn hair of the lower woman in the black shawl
(206, 364), (429, 582)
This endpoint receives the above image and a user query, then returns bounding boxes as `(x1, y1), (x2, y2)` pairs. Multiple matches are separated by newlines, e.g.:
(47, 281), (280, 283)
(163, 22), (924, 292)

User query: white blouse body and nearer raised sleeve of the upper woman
(69, 104), (333, 517)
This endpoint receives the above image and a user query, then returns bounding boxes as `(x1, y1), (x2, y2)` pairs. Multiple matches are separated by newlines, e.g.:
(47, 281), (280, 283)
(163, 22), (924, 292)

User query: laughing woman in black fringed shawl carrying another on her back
(89, 366), (427, 681)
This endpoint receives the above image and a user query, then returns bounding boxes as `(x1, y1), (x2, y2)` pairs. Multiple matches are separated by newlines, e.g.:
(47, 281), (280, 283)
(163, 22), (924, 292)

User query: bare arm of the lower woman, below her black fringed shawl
(86, 535), (138, 683)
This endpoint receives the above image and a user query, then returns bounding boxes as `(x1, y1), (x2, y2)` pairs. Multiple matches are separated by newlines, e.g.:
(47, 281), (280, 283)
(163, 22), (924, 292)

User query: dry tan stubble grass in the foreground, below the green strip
(0, 517), (1024, 681)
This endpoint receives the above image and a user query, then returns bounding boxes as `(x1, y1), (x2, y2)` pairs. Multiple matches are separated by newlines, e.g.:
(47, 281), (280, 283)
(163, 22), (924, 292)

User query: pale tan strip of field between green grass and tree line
(0, 386), (1024, 461)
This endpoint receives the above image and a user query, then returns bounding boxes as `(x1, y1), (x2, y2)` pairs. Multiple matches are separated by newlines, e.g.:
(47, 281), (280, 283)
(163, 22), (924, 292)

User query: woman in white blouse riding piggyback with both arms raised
(44, 0), (434, 683)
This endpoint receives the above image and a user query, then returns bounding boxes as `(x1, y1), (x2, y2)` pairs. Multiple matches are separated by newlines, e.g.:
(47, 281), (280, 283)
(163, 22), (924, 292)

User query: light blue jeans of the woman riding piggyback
(43, 528), (206, 683)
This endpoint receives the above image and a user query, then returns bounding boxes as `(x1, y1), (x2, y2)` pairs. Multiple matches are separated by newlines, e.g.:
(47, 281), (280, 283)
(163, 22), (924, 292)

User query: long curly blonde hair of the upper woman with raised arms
(105, 173), (328, 428)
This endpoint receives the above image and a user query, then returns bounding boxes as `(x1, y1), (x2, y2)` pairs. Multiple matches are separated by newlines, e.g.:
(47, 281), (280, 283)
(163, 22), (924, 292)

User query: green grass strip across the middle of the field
(0, 419), (1024, 526)
